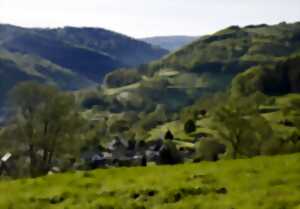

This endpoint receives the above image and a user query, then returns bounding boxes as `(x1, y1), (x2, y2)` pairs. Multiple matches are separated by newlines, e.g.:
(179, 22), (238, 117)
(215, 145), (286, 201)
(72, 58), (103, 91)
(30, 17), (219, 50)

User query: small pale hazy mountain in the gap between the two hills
(141, 36), (199, 51)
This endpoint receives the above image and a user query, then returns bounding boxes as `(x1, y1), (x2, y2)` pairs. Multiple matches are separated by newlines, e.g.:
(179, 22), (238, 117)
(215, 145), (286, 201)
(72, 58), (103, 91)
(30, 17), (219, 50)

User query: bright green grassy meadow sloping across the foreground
(0, 154), (300, 209)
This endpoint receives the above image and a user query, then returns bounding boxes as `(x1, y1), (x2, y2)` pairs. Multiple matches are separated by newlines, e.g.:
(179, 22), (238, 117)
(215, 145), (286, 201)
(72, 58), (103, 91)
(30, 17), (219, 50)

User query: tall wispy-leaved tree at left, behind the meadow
(5, 82), (81, 176)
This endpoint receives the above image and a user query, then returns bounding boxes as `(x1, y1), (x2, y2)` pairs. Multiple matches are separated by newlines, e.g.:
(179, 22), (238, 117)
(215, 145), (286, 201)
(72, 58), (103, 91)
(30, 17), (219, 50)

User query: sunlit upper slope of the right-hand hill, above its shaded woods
(154, 23), (300, 73)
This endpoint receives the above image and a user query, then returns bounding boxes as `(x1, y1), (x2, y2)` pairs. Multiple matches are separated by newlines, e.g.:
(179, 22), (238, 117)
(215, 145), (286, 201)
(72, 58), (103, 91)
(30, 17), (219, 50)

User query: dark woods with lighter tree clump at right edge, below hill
(231, 56), (300, 98)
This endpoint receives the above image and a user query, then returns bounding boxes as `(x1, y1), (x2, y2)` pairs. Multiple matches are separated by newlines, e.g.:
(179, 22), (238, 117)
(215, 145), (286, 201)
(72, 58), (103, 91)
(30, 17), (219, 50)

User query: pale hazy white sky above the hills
(0, 0), (300, 37)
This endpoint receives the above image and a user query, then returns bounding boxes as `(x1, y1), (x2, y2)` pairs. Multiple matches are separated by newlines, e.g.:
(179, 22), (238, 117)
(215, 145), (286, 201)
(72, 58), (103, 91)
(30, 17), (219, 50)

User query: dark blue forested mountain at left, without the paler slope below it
(0, 25), (167, 81)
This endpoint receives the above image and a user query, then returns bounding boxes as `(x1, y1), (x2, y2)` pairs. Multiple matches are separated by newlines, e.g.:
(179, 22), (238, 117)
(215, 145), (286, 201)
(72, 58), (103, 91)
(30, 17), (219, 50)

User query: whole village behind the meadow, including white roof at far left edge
(0, 130), (216, 176)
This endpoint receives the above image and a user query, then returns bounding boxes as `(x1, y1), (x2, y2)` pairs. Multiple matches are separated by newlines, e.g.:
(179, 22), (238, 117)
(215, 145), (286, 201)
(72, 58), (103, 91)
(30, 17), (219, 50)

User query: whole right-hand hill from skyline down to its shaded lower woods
(100, 23), (300, 111)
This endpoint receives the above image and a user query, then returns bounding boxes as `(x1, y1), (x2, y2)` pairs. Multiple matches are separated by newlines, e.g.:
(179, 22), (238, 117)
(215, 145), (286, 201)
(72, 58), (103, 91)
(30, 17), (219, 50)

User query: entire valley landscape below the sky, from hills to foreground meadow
(0, 22), (300, 209)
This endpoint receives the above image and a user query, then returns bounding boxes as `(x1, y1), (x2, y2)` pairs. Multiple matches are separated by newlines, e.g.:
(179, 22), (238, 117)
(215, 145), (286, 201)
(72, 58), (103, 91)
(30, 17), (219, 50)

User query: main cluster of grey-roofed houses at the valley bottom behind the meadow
(81, 133), (195, 169)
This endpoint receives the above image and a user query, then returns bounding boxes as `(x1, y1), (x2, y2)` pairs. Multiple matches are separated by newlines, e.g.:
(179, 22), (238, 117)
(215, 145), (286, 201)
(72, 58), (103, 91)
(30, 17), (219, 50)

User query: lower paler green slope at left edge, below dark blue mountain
(0, 50), (96, 106)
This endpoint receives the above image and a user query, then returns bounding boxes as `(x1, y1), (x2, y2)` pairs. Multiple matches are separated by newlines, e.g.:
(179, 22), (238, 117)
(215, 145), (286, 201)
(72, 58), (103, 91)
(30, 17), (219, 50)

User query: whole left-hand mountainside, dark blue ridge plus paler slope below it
(0, 24), (168, 109)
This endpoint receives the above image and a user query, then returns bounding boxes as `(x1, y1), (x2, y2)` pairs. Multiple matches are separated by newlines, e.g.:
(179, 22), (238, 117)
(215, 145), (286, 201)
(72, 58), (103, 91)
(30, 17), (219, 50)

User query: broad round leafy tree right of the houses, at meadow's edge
(213, 98), (273, 159)
